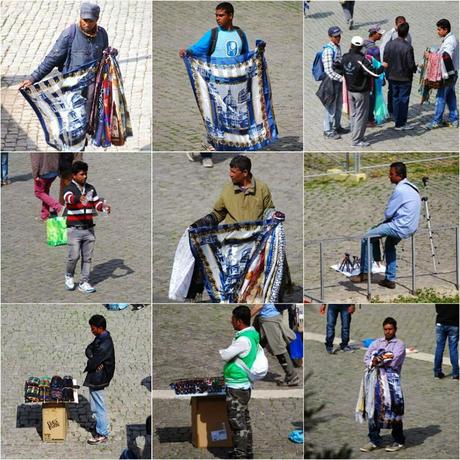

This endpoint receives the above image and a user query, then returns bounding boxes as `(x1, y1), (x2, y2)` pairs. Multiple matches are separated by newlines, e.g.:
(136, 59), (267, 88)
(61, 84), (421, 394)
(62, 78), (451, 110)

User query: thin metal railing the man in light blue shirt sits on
(305, 225), (460, 302)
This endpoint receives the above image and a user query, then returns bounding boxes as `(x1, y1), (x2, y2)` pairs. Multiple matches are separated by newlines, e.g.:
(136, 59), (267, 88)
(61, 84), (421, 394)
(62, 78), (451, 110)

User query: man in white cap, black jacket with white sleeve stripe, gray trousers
(342, 36), (386, 147)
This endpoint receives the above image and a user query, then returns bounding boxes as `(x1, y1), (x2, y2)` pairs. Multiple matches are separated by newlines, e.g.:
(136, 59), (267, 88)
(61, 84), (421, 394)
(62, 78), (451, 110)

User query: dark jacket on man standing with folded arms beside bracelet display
(83, 331), (115, 390)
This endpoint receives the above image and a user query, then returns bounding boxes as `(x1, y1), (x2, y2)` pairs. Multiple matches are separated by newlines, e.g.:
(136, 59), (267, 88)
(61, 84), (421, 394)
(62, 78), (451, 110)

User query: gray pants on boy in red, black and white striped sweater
(66, 227), (96, 283)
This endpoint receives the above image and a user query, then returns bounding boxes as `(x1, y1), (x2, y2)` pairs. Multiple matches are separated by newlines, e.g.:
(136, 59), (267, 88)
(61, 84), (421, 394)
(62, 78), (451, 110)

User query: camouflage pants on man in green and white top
(226, 387), (253, 458)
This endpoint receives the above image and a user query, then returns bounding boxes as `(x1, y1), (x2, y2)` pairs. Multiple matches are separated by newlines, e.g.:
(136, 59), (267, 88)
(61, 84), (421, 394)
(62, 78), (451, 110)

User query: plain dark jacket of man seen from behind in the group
(383, 37), (417, 82)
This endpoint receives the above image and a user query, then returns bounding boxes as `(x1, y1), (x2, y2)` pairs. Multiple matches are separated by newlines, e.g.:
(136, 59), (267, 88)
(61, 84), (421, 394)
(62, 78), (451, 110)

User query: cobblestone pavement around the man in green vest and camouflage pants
(153, 304), (303, 458)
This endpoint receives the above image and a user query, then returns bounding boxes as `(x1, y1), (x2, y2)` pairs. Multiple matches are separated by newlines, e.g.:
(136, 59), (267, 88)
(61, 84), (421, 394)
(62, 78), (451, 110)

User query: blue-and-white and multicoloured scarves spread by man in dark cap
(19, 48), (132, 152)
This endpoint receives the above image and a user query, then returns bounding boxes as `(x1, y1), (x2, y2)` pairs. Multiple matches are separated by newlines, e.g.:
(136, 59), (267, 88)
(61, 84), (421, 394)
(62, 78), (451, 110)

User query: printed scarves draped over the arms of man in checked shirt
(355, 350), (404, 428)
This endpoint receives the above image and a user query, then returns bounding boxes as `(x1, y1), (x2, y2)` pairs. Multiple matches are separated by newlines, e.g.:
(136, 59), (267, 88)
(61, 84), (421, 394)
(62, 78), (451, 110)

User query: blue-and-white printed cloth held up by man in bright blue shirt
(184, 41), (278, 151)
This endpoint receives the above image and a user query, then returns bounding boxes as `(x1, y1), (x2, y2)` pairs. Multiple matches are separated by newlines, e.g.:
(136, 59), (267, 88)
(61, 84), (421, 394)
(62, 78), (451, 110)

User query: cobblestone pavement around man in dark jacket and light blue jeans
(1, 304), (152, 459)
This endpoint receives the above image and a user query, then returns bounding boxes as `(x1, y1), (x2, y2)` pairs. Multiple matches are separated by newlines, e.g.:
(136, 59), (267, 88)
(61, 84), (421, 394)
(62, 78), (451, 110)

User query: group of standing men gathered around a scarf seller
(317, 15), (458, 147)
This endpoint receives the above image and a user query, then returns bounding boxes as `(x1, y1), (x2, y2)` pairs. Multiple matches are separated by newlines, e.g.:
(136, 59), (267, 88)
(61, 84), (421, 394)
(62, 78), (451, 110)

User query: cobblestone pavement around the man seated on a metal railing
(304, 156), (458, 302)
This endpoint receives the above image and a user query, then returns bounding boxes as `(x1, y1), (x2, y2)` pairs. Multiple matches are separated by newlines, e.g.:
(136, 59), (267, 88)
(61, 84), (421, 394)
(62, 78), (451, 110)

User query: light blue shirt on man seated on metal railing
(385, 179), (421, 238)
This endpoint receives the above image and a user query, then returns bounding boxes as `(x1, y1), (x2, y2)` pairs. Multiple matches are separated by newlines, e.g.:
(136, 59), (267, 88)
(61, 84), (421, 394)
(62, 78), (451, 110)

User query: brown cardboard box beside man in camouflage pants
(190, 396), (232, 447)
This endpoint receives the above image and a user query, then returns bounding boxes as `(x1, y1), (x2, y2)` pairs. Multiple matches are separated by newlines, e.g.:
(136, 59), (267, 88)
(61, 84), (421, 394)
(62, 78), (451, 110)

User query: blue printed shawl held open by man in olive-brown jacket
(189, 219), (285, 303)
